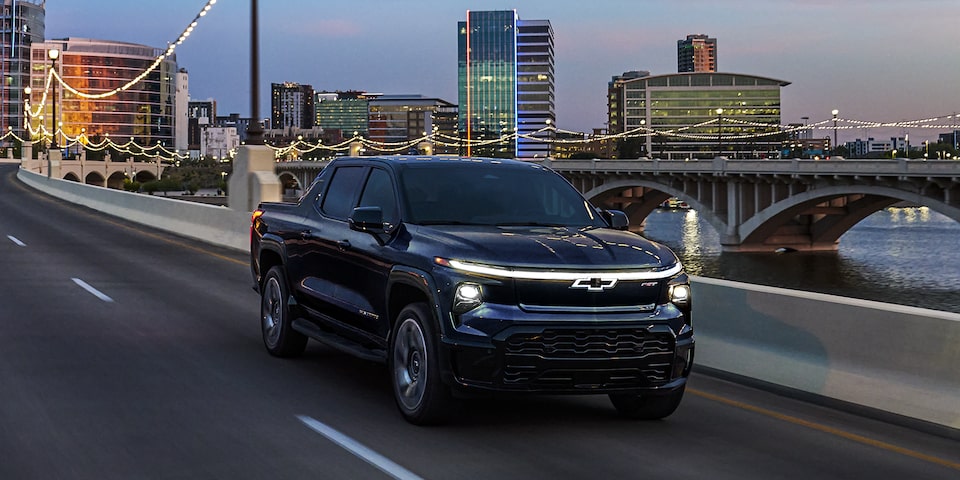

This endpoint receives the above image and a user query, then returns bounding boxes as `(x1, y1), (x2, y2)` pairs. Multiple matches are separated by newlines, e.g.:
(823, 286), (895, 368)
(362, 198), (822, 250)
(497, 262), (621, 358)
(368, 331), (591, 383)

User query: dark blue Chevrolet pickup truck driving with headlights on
(250, 156), (694, 424)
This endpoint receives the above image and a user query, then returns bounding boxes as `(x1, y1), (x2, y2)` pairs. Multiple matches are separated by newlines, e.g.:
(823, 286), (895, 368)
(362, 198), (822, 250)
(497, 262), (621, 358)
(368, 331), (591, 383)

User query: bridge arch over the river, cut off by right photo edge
(736, 185), (960, 251)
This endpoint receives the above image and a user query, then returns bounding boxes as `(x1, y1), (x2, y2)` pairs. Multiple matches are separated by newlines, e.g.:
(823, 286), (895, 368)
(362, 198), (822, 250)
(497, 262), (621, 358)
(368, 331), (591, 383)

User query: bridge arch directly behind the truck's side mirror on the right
(584, 178), (727, 237)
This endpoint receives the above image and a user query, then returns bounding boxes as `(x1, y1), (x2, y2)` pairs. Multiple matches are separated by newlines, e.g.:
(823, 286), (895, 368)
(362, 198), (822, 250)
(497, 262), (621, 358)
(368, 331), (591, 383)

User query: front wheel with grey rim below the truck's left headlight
(387, 303), (453, 425)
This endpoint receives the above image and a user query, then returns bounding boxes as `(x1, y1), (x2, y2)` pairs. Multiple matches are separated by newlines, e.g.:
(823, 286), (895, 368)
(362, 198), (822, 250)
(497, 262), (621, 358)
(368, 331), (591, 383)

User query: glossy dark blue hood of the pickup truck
(408, 225), (677, 270)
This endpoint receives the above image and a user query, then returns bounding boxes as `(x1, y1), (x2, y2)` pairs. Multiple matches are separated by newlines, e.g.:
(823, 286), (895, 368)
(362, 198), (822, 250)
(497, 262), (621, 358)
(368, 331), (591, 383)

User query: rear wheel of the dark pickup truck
(260, 266), (307, 357)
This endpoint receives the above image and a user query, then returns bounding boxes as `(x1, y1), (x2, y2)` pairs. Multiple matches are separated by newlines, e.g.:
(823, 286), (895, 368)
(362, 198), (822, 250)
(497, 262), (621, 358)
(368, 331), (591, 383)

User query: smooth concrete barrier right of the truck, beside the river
(693, 277), (960, 429)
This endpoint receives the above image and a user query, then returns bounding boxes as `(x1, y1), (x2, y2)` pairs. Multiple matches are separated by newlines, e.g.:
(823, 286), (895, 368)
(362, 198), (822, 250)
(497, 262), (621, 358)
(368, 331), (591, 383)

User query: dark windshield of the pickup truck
(400, 162), (604, 227)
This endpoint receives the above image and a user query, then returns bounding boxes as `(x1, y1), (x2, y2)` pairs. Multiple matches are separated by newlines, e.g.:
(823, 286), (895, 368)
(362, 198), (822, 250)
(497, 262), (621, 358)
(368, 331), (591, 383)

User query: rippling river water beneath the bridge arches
(644, 207), (960, 313)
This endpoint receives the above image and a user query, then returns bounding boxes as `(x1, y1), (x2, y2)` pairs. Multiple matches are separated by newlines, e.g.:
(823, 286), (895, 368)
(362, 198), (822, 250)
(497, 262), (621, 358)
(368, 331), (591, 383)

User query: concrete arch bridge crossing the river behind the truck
(255, 157), (960, 252)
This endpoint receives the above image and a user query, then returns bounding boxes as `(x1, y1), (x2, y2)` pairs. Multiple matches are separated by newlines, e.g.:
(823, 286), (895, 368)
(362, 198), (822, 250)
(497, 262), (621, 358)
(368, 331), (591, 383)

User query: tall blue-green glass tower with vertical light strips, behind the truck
(458, 10), (556, 158)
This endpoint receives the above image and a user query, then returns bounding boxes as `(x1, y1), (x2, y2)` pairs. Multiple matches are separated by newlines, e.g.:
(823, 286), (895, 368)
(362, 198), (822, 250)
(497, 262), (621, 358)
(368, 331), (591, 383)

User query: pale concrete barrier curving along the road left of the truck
(17, 168), (250, 251)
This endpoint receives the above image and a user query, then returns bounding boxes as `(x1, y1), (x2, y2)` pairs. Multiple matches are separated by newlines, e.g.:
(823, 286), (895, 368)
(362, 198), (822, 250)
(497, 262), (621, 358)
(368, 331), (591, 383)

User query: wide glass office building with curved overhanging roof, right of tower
(608, 73), (790, 158)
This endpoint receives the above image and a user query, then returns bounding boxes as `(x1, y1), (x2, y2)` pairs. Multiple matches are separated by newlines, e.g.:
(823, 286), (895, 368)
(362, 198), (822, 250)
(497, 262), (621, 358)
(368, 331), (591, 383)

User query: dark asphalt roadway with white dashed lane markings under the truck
(0, 165), (960, 479)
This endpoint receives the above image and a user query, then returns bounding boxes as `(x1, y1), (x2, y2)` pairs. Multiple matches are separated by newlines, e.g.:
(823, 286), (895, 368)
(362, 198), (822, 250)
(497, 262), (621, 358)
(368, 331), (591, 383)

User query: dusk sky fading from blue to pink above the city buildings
(46, 0), (960, 143)
